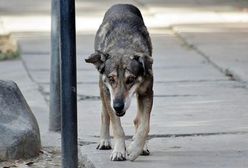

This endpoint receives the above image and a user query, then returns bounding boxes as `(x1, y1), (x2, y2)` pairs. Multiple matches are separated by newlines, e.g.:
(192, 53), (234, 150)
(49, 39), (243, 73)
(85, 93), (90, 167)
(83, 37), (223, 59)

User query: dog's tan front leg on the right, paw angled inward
(127, 91), (153, 161)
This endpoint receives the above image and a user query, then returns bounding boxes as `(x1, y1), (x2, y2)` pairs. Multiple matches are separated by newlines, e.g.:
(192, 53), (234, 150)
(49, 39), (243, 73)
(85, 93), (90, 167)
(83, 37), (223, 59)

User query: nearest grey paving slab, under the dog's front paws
(81, 135), (248, 168)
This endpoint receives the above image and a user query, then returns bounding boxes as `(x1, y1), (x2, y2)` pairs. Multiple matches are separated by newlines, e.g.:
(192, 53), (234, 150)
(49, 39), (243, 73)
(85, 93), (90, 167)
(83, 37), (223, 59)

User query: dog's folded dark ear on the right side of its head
(134, 53), (153, 75)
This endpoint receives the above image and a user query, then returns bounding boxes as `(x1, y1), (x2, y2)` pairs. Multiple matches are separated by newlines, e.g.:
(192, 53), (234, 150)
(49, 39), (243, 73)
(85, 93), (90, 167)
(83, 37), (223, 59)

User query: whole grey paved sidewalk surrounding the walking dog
(0, 0), (248, 168)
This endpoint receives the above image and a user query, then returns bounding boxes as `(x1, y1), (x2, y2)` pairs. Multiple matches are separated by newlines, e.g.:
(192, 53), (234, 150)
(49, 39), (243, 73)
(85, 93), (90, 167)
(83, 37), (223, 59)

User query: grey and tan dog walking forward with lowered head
(85, 4), (153, 161)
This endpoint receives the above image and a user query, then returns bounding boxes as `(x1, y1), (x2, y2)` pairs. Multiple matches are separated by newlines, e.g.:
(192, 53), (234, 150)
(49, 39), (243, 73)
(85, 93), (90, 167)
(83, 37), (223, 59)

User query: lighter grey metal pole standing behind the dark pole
(49, 0), (61, 132)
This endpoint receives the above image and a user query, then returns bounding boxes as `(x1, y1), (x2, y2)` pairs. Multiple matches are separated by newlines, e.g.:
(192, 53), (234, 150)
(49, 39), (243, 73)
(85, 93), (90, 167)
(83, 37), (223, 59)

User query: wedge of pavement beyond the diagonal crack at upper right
(174, 23), (248, 82)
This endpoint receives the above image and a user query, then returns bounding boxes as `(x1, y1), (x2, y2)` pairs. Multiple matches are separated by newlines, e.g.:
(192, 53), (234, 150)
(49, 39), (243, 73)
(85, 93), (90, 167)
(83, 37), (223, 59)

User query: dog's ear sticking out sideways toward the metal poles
(85, 51), (109, 73)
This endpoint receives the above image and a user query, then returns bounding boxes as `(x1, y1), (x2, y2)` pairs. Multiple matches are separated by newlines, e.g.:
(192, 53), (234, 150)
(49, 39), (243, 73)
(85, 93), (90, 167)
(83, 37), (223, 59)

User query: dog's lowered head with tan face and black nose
(85, 51), (153, 117)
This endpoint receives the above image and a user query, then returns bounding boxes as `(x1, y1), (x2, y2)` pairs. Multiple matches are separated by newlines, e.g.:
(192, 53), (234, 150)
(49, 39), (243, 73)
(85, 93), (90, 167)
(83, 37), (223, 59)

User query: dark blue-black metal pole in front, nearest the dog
(60, 0), (78, 168)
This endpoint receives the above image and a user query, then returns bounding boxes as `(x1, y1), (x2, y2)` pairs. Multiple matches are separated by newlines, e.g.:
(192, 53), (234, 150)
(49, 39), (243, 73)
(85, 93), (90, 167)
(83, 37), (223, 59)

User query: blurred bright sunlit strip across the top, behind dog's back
(0, 0), (248, 32)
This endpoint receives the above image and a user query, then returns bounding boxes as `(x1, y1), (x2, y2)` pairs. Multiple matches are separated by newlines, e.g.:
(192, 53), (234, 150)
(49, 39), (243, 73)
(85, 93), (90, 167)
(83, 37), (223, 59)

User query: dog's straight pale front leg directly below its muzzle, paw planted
(110, 112), (126, 161)
